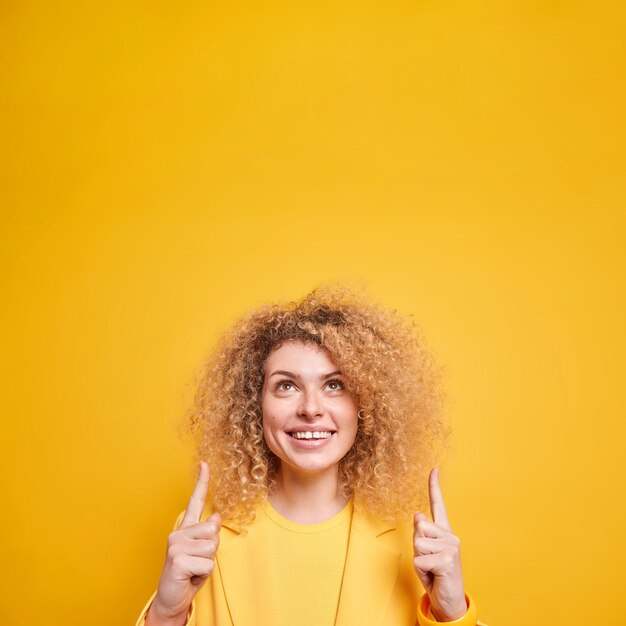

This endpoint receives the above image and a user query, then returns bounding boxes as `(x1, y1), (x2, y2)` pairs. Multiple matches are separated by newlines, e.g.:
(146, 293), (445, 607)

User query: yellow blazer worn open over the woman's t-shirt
(137, 507), (486, 626)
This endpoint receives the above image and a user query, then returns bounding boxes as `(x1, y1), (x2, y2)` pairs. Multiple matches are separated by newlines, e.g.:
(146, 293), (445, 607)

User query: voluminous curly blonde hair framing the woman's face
(183, 286), (449, 525)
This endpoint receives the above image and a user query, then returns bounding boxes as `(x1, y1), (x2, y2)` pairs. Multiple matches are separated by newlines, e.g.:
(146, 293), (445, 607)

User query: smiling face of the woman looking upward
(263, 341), (358, 473)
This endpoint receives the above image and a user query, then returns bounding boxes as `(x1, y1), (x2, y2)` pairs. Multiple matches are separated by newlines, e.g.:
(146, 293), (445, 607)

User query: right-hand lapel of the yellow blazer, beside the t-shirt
(335, 507), (400, 626)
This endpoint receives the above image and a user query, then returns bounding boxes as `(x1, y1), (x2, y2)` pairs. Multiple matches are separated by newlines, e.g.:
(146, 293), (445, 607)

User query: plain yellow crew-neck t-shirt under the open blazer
(260, 500), (352, 626)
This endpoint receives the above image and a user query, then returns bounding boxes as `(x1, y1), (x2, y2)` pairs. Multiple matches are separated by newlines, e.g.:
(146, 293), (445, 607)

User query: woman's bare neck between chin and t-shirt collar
(269, 465), (348, 524)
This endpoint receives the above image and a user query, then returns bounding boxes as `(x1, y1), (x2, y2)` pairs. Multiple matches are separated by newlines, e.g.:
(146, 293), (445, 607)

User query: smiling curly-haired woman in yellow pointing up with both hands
(137, 288), (488, 626)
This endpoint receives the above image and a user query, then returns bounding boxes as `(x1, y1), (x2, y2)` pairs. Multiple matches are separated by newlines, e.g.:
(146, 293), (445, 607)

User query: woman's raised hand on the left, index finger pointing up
(146, 461), (221, 626)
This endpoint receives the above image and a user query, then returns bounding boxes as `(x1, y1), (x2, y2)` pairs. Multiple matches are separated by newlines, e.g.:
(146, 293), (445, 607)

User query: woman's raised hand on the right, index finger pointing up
(413, 467), (467, 622)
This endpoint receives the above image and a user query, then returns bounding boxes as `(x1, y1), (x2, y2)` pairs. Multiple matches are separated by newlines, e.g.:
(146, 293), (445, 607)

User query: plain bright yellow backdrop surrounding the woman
(0, 0), (626, 626)
